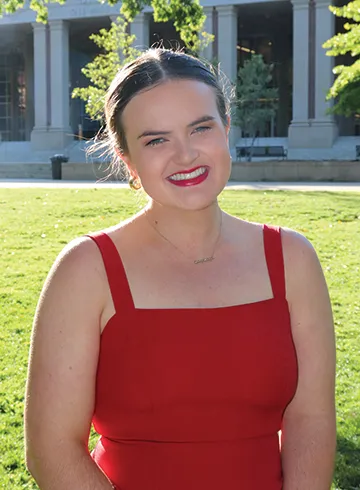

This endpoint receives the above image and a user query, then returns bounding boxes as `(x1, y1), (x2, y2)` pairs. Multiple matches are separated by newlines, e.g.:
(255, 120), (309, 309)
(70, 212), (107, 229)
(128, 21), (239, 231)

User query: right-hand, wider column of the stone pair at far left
(49, 20), (73, 149)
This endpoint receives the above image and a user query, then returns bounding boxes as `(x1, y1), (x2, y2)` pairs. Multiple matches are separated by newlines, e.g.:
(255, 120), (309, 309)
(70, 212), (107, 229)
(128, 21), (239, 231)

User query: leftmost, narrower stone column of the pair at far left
(30, 22), (49, 150)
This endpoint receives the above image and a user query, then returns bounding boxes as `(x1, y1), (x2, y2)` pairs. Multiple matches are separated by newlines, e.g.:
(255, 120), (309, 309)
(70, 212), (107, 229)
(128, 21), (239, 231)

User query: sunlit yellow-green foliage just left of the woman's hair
(72, 17), (141, 120)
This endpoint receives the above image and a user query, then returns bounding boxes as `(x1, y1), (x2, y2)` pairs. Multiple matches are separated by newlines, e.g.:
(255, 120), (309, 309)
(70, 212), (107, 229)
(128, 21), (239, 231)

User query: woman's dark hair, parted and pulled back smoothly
(101, 48), (230, 167)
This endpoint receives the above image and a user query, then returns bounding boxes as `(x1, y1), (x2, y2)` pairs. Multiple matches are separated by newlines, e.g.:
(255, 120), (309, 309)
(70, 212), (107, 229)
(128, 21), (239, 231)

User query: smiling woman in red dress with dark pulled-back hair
(25, 49), (335, 490)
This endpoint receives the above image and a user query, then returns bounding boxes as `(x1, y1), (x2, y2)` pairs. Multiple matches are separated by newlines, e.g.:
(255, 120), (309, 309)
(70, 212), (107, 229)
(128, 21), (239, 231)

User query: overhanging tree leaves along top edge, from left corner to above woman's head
(0, 0), (212, 52)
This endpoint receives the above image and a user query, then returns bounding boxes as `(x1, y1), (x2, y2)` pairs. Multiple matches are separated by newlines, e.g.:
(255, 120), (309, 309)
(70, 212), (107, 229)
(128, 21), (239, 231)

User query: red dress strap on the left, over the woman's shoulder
(86, 231), (134, 313)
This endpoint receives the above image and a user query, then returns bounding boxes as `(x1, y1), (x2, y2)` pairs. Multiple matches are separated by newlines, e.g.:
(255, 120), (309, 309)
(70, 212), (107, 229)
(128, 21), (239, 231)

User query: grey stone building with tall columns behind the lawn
(0, 0), (360, 163)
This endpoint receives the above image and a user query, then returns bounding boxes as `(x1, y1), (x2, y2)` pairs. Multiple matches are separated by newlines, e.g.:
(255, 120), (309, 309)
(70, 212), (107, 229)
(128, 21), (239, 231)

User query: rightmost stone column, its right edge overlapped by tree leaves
(312, 0), (338, 148)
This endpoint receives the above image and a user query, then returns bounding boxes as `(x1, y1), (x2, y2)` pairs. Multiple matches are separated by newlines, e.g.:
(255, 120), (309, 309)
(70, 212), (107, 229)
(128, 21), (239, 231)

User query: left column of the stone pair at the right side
(288, 0), (310, 148)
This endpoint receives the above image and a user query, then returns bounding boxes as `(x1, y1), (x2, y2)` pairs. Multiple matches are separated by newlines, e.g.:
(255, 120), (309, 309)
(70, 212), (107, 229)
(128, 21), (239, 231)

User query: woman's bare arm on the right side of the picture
(282, 230), (336, 490)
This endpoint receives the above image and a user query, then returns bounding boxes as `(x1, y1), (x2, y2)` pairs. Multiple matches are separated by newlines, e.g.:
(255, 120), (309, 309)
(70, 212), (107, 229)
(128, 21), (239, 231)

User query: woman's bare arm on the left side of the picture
(25, 238), (112, 490)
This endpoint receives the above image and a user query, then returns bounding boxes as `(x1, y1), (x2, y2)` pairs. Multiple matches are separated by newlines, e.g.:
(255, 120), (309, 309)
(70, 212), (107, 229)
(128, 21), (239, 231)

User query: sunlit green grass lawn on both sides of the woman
(0, 189), (360, 490)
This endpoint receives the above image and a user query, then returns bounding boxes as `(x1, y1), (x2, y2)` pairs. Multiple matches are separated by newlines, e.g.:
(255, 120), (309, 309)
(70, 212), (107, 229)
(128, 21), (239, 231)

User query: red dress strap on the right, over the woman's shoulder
(263, 225), (286, 298)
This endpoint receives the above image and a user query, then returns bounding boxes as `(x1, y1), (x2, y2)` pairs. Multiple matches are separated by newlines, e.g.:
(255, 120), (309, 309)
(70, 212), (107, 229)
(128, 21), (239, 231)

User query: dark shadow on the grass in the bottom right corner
(334, 436), (360, 490)
